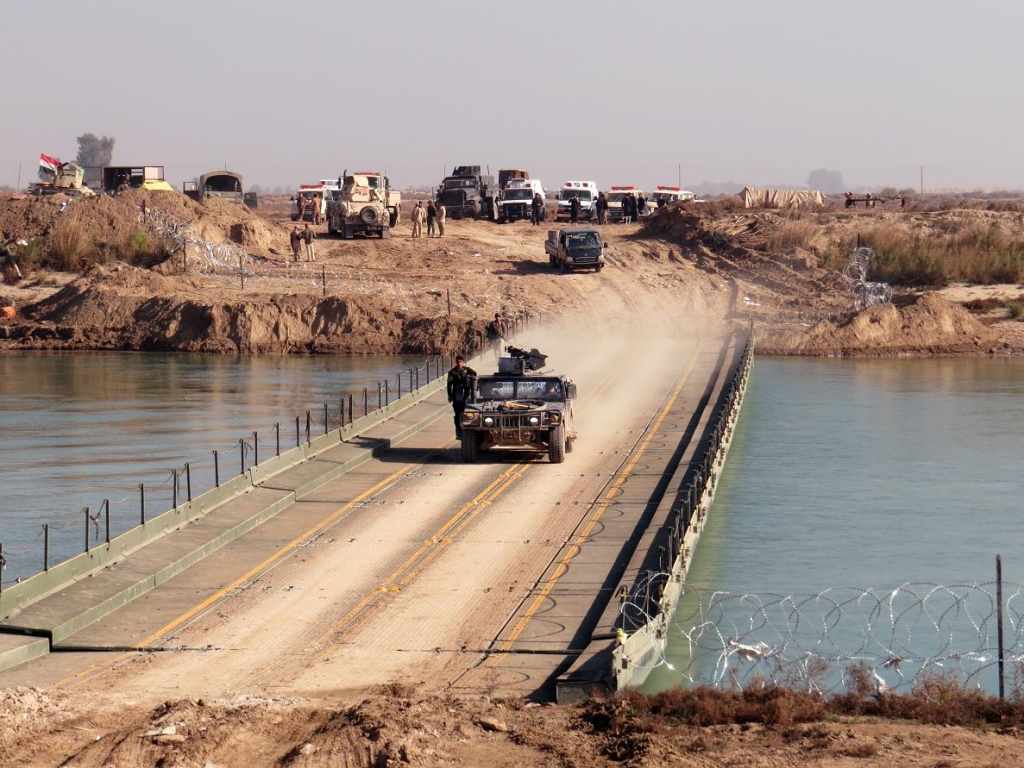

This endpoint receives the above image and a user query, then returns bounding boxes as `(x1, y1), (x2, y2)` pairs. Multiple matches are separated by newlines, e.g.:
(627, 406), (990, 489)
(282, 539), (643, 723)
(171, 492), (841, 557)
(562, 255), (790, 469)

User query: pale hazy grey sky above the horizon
(0, 0), (1024, 189)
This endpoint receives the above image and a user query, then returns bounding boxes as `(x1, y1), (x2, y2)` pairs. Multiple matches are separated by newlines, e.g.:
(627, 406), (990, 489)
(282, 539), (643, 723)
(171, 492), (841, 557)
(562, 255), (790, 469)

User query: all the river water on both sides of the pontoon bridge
(0, 353), (1024, 689)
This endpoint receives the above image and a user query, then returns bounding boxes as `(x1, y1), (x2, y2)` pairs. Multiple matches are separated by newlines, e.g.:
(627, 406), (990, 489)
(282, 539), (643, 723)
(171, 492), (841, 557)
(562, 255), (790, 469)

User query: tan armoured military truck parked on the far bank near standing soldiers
(325, 170), (401, 240)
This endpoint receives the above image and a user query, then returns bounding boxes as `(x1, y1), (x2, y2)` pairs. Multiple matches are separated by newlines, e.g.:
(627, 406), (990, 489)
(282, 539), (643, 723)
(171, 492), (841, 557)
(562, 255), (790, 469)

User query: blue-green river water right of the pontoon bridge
(645, 358), (1024, 690)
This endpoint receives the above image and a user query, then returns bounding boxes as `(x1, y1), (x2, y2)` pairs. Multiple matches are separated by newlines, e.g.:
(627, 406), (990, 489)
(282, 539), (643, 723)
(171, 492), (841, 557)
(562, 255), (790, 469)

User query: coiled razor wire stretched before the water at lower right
(622, 573), (1024, 693)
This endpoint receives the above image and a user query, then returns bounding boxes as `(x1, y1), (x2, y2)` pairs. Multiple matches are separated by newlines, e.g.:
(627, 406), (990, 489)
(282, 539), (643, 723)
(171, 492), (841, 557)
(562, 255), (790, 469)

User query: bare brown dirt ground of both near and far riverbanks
(0, 193), (1024, 766)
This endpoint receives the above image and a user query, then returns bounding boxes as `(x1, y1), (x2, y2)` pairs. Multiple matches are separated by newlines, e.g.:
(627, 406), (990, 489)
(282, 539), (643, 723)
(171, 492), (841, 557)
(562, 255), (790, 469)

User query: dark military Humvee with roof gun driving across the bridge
(462, 346), (577, 464)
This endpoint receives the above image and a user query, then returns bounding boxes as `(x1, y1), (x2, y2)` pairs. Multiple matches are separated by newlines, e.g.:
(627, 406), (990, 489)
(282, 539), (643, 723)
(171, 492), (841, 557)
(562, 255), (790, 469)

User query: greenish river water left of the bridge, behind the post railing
(0, 353), (423, 584)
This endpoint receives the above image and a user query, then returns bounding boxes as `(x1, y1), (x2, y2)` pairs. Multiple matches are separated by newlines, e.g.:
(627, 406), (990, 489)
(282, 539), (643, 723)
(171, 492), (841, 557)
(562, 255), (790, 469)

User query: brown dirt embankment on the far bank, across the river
(0, 191), (1024, 355)
